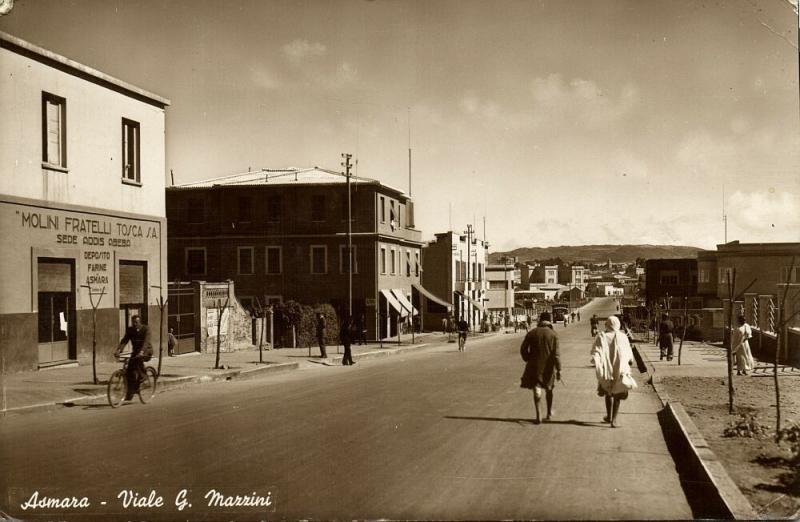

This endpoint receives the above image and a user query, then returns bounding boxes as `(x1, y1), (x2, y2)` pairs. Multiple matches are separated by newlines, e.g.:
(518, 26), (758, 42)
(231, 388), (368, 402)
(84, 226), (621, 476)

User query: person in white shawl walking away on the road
(591, 316), (637, 428)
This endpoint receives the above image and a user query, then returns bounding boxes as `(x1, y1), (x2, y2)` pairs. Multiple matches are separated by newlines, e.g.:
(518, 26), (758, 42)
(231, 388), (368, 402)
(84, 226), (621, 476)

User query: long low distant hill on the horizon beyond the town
(489, 245), (703, 263)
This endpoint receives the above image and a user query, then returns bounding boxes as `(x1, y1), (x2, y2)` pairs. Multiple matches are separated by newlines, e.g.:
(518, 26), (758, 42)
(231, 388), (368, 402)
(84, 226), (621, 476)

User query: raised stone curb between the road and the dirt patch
(634, 347), (758, 520)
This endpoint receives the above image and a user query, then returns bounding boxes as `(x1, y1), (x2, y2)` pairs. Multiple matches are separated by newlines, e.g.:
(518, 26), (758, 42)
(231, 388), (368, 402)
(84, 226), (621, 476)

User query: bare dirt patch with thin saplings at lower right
(662, 375), (800, 518)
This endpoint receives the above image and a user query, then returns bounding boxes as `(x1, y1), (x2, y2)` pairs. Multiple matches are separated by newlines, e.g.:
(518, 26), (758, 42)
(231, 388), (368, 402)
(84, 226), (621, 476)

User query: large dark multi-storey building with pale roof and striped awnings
(167, 167), (422, 339)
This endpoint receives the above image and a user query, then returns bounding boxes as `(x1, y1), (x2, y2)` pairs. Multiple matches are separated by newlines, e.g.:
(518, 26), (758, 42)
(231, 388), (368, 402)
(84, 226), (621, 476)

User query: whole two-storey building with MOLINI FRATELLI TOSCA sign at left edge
(0, 32), (169, 372)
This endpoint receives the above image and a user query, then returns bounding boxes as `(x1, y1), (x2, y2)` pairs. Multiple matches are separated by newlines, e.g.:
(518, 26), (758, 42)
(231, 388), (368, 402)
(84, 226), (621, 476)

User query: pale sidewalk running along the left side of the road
(0, 331), (502, 416)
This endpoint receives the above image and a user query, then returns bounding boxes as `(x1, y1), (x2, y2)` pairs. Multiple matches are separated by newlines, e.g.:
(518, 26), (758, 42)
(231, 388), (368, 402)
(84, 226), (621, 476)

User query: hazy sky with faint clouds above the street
(0, 0), (800, 251)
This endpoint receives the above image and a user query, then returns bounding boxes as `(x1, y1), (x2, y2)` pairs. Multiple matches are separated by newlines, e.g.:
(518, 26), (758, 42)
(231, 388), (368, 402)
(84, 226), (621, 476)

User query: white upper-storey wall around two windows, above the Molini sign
(0, 37), (166, 217)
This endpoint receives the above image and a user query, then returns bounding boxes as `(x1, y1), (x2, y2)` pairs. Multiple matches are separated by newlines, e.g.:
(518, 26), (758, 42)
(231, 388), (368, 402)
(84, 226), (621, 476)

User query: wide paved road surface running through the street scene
(0, 301), (692, 520)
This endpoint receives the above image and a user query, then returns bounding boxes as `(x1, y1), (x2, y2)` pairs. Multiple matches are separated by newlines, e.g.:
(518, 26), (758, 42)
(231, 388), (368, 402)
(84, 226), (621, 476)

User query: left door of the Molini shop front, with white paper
(37, 258), (75, 365)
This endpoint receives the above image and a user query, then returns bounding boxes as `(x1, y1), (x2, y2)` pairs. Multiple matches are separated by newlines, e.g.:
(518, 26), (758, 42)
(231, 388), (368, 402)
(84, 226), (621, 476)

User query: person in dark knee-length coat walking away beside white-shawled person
(519, 312), (561, 424)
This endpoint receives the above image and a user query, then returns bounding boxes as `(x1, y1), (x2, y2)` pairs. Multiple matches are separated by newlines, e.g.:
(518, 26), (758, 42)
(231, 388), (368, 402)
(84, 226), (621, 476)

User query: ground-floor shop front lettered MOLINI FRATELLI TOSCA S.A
(0, 196), (167, 372)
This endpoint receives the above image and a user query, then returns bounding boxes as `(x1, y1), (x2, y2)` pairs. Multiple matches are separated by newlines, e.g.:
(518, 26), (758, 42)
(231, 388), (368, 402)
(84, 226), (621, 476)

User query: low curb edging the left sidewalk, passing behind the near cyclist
(0, 362), (300, 417)
